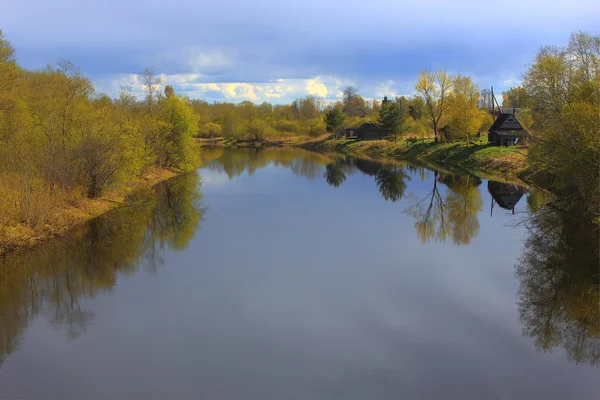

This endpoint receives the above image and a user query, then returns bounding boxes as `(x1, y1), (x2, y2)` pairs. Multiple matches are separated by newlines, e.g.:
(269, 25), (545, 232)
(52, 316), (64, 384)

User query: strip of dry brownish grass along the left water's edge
(0, 168), (180, 256)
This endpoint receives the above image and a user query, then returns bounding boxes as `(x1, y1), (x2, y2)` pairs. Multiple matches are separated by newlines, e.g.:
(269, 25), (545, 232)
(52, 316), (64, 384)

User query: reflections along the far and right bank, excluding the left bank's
(203, 149), (600, 364)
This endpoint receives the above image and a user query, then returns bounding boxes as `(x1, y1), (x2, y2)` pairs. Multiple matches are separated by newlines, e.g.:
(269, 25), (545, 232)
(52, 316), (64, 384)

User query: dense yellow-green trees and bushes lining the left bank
(0, 31), (198, 245)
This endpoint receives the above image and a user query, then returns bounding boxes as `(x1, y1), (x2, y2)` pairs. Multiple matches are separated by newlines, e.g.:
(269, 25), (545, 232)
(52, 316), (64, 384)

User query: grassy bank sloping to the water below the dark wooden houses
(197, 135), (545, 186)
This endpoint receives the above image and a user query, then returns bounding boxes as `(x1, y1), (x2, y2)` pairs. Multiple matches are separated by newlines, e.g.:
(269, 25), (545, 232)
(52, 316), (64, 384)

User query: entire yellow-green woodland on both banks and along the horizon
(0, 31), (600, 248)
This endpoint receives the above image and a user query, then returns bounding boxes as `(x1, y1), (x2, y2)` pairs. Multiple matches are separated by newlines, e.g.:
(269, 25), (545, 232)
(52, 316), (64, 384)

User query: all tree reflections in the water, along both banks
(0, 148), (600, 376)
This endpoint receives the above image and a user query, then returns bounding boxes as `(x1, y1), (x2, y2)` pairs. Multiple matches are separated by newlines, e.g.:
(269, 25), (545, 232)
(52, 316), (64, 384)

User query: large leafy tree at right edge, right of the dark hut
(523, 32), (600, 219)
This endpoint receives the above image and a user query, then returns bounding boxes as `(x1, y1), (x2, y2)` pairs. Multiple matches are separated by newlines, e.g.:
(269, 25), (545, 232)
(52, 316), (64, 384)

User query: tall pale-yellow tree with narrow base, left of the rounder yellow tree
(415, 71), (452, 140)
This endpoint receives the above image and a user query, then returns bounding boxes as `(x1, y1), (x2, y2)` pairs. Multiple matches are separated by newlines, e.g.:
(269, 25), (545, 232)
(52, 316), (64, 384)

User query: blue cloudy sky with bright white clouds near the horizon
(0, 0), (600, 103)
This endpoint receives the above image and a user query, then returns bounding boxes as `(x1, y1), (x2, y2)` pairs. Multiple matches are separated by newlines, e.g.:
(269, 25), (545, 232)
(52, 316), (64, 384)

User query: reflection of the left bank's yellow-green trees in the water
(0, 174), (203, 365)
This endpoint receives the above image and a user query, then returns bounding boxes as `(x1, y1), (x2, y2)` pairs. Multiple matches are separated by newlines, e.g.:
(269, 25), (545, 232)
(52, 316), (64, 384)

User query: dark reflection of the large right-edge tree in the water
(516, 198), (600, 365)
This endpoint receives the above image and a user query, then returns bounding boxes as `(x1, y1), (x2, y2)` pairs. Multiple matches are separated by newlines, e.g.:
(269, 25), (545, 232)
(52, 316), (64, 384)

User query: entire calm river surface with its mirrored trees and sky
(0, 149), (600, 399)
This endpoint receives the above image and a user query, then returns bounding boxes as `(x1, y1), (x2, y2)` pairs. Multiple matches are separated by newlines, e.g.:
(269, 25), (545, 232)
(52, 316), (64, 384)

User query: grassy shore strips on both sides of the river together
(0, 137), (549, 257)
